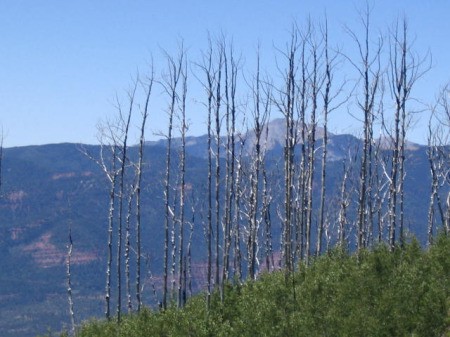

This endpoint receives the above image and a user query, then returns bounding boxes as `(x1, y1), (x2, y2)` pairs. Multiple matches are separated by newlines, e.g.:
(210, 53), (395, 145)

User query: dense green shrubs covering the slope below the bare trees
(61, 237), (450, 337)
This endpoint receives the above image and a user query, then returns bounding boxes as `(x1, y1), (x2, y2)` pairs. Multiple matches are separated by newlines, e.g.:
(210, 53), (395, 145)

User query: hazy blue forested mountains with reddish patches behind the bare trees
(0, 120), (442, 337)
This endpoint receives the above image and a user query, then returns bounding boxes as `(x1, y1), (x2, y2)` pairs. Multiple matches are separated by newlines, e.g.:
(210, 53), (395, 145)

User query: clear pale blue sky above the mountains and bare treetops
(0, 0), (450, 147)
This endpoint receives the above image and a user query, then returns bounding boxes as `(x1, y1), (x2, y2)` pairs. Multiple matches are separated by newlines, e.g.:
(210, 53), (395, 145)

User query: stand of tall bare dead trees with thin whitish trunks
(72, 5), (450, 330)
